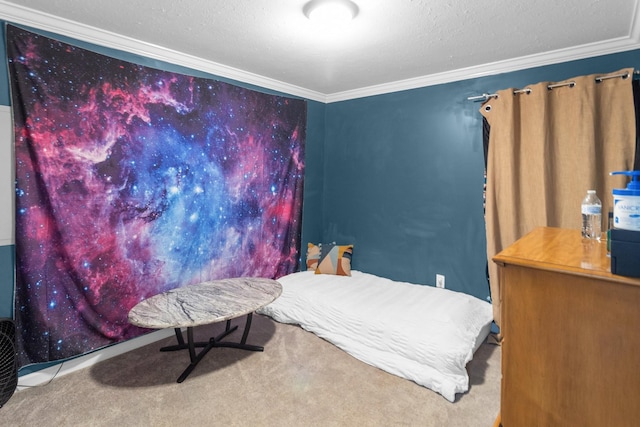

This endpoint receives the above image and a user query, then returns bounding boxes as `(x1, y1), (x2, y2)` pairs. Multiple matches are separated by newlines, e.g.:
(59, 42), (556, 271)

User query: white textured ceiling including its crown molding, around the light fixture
(0, 0), (640, 102)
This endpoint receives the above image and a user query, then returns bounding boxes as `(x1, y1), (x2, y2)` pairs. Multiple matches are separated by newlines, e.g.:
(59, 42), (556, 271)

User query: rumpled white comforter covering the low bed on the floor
(258, 271), (493, 402)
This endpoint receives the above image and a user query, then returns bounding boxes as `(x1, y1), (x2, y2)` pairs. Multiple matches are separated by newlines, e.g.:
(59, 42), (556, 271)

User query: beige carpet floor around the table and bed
(0, 315), (500, 427)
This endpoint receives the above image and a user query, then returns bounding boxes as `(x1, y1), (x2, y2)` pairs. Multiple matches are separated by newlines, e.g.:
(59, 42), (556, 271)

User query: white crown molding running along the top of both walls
(0, 0), (640, 103)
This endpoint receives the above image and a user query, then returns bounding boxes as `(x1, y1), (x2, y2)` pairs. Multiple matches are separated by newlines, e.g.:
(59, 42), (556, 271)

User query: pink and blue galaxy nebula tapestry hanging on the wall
(7, 26), (306, 366)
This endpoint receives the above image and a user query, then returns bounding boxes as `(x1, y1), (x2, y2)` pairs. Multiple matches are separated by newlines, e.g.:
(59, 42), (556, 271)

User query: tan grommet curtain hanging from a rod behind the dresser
(480, 69), (635, 325)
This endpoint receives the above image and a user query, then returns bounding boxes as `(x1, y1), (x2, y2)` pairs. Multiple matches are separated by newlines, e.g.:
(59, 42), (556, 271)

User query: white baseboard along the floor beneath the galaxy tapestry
(17, 329), (174, 391)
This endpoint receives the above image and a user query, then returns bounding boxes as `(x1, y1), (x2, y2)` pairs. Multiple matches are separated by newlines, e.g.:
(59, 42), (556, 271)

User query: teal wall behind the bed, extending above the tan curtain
(322, 50), (640, 298)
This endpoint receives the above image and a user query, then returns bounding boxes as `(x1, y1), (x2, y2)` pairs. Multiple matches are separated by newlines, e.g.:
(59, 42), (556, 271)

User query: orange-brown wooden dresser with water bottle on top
(493, 227), (640, 427)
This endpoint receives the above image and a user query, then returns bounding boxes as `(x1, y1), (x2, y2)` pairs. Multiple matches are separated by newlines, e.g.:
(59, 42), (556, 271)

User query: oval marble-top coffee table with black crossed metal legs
(129, 277), (282, 383)
